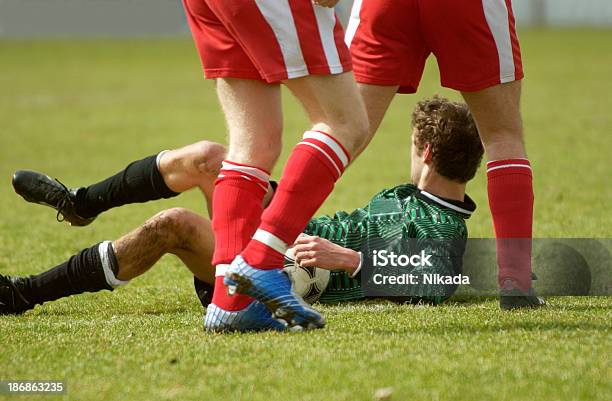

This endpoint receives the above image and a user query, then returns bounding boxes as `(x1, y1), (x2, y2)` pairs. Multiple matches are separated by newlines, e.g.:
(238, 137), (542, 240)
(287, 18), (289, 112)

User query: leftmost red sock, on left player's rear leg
(212, 160), (270, 311)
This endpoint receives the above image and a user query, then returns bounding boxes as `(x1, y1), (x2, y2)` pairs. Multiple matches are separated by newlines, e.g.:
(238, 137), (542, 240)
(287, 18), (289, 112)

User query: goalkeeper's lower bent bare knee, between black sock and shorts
(113, 208), (215, 283)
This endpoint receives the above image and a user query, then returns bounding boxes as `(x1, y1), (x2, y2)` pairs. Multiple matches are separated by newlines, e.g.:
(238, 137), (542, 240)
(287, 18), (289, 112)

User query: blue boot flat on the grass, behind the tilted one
(204, 301), (287, 332)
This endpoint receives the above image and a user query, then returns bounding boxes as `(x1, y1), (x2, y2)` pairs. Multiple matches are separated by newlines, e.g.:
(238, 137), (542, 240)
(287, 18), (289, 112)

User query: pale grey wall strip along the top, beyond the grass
(0, 0), (612, 37)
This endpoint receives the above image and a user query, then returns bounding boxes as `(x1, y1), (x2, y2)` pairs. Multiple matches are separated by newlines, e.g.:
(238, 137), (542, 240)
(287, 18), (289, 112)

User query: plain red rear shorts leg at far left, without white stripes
(183, 0), (263, 80)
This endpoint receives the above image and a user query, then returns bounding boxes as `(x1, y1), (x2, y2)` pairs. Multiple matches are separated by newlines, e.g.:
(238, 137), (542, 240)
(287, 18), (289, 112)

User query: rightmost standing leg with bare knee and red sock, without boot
(463, 81), (534, 290)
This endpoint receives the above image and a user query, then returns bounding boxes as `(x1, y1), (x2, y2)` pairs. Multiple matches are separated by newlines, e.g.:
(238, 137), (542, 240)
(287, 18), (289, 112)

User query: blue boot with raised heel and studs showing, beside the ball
(223, 255), (325, 331)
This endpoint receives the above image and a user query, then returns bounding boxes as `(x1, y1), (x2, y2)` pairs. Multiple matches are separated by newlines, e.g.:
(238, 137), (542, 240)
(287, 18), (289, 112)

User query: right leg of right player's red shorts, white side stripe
(420, 0), (523, 92)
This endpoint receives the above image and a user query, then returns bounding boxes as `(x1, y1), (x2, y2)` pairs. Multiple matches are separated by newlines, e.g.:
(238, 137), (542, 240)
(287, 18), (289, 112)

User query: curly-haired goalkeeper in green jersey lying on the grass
(0, 97), (483, 314)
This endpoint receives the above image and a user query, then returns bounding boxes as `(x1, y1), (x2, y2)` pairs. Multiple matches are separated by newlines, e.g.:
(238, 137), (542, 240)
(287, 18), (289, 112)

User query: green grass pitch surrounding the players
(0, 30), (612, 401)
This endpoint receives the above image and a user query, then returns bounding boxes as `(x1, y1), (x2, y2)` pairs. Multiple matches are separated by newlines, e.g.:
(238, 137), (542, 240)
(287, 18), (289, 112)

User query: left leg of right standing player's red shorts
(346, 0), (430, 93)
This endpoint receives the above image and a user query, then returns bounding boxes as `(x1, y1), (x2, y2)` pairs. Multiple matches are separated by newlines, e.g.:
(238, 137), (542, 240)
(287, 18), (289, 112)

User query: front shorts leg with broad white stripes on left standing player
(207, 0), (351, 83)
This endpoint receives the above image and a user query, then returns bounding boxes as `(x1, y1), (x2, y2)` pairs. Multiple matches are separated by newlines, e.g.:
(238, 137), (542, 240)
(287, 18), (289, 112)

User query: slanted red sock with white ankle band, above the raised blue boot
(242, 131), (350, 269)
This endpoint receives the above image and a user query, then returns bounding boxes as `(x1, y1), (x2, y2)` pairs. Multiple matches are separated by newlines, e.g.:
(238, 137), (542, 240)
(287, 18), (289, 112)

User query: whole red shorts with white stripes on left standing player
(183, 0), (351, 83)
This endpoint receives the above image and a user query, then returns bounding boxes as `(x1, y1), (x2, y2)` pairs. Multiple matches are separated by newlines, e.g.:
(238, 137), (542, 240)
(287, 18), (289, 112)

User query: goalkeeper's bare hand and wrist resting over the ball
(293, 235), (360, 273)
